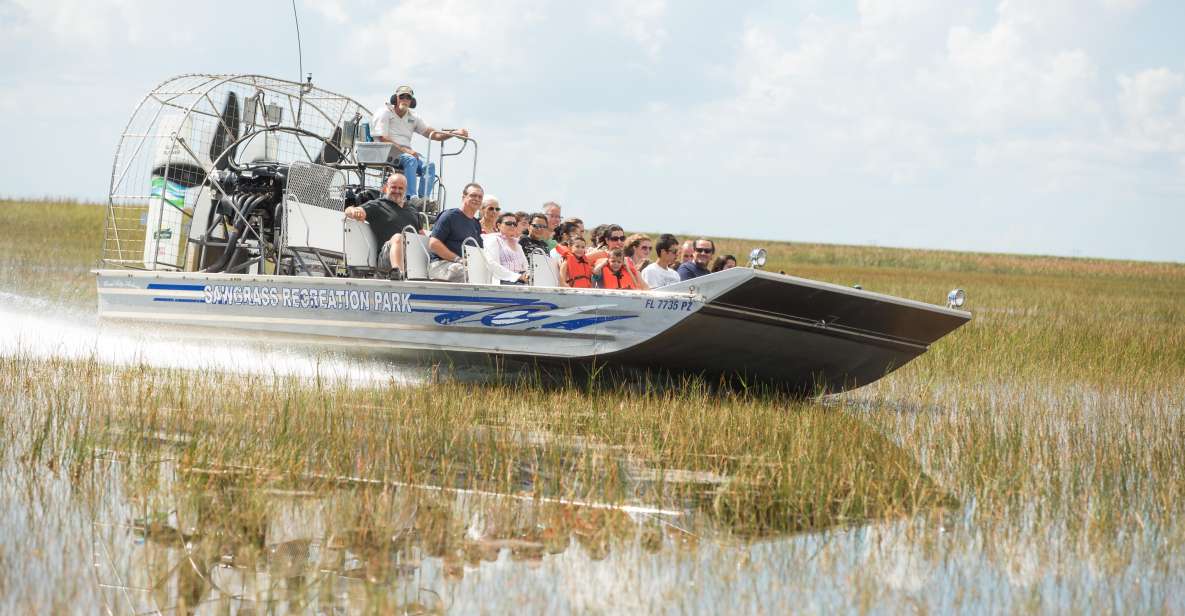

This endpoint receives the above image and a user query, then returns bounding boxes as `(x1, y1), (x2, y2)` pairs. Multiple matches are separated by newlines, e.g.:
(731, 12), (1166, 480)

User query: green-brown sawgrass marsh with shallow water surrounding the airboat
(0, 203), (1185, 614)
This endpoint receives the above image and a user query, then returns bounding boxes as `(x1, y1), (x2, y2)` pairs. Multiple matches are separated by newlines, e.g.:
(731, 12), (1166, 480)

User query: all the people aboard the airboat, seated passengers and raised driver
(345, 85), (737, 290)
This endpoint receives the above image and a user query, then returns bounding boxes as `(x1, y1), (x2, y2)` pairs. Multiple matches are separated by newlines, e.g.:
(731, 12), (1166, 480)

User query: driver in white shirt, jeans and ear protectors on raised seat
(371, 85), (469, 199)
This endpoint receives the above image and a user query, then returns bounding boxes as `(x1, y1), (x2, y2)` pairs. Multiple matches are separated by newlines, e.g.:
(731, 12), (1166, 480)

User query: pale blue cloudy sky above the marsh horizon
(0, 0), (1185, 262)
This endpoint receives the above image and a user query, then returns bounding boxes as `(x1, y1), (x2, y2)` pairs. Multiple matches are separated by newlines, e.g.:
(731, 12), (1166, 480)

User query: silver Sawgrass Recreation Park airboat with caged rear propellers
(96, 75), (971, 393)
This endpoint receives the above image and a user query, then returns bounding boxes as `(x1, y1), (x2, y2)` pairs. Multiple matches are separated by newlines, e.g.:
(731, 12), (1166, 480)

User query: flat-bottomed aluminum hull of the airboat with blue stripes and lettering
(96, 268), (971, 393)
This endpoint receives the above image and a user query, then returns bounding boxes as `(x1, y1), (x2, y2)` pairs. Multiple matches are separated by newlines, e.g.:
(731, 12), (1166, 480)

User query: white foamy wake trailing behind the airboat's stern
(0, 291), (428, 385)
